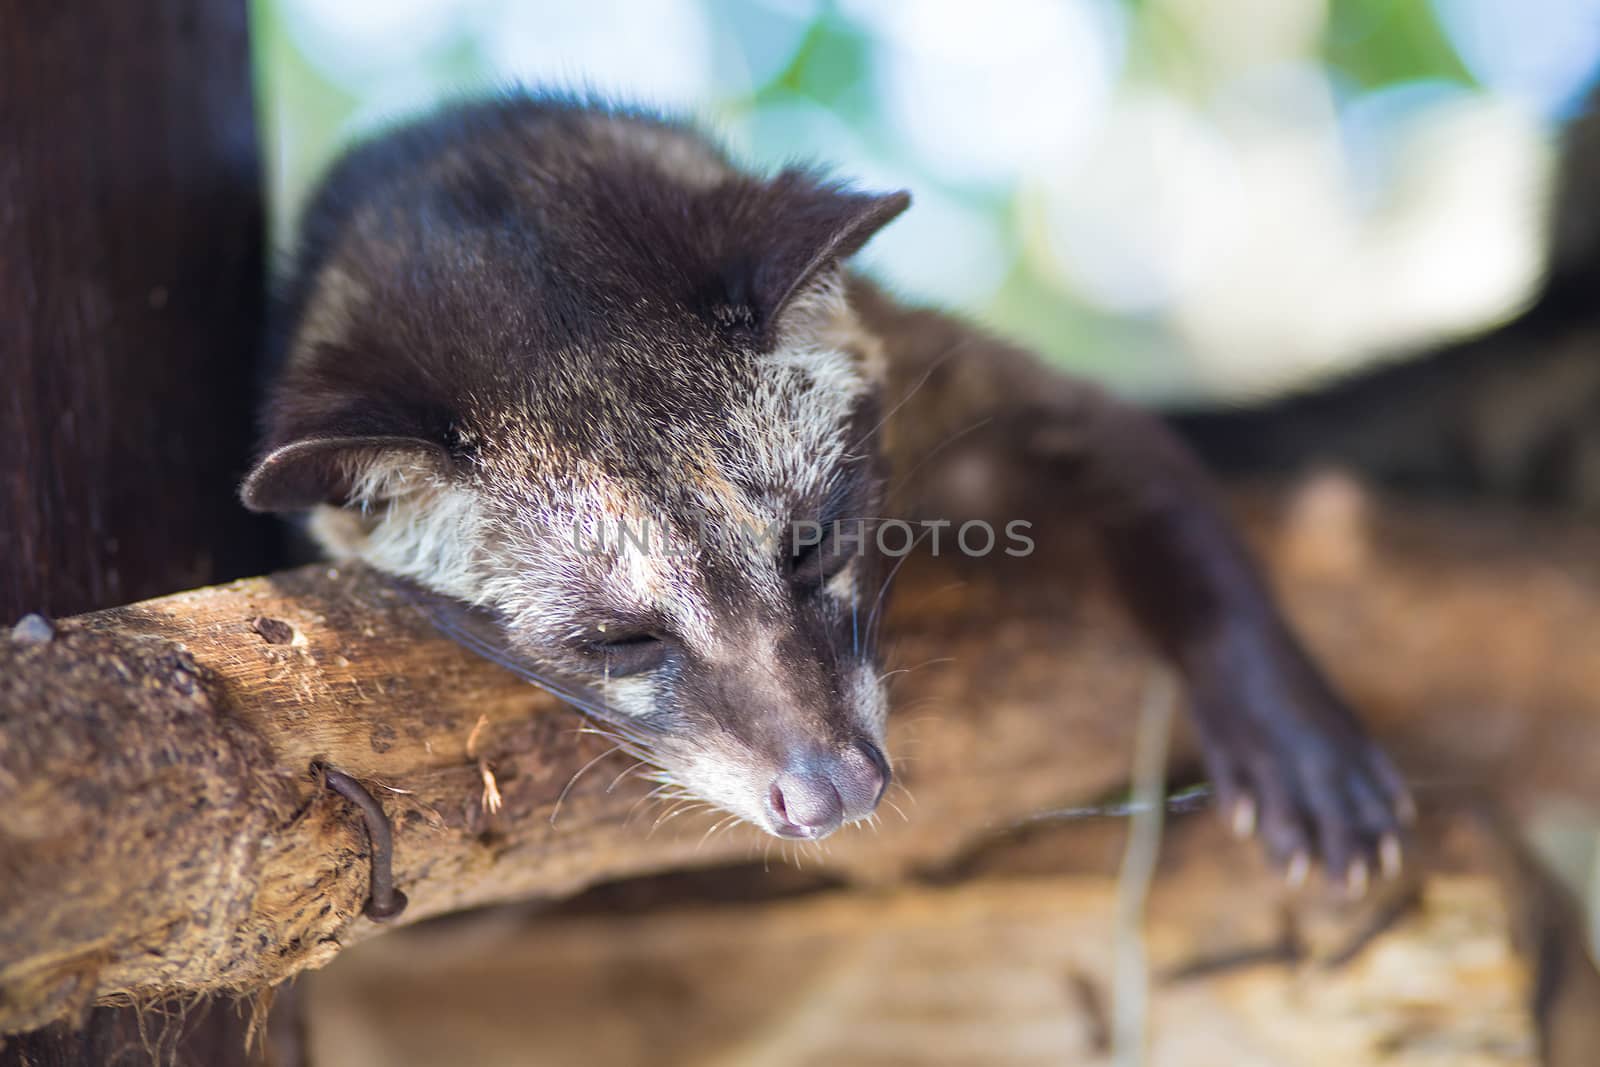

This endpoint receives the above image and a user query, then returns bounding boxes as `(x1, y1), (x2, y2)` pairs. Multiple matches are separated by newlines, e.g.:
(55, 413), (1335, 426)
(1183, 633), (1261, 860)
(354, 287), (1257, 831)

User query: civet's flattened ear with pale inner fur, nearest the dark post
(238, 437), (450, 512)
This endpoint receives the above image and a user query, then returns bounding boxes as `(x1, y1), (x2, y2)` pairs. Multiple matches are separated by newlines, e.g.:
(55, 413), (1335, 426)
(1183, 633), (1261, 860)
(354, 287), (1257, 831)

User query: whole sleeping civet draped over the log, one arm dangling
(242, 93), (1408, 883)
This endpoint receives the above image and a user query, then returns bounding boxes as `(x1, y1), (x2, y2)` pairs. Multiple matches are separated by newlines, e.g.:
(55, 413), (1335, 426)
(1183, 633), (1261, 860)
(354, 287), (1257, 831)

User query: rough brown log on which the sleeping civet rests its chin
(0, 480), (1600, 1032)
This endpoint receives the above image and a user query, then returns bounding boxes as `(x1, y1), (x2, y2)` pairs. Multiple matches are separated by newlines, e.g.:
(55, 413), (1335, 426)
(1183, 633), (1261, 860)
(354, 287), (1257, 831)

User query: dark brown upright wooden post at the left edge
(0, 0), (274, 1064)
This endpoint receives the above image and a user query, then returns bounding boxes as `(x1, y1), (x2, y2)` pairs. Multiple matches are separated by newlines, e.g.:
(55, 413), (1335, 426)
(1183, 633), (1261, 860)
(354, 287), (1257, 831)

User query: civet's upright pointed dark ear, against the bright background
(730, 171), (910, 334)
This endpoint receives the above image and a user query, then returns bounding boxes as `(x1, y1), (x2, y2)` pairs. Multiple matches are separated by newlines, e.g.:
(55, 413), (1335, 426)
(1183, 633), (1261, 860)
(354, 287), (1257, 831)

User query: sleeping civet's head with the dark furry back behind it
(243, 99), (909, 838)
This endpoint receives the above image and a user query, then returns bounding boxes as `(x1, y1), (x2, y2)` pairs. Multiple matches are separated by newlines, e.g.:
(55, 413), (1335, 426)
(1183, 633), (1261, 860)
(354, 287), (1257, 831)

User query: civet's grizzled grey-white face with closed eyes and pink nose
(305, 283), (890, 838)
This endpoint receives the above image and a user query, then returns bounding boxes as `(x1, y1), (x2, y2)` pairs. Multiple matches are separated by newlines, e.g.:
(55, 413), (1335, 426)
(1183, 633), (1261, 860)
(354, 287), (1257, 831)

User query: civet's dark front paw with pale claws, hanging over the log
(1190, 649), (1413, 896)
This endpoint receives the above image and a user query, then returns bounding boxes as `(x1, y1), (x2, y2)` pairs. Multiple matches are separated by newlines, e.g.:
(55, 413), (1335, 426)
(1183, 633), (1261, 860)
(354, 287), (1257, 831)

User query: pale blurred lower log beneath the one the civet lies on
(306, 817), (1548, 1067)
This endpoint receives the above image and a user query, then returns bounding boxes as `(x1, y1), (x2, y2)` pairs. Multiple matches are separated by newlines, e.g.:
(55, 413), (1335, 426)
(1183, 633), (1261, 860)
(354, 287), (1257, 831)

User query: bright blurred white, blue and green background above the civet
(253, 0), (1600, 395)
